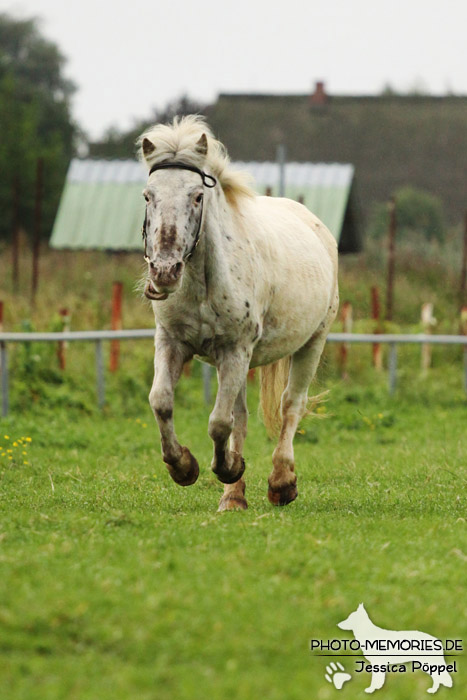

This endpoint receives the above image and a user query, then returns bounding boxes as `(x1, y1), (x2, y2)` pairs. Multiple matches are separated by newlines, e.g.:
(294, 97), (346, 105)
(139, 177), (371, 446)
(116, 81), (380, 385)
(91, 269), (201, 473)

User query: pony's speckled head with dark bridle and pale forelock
(138, 116), (254, 300)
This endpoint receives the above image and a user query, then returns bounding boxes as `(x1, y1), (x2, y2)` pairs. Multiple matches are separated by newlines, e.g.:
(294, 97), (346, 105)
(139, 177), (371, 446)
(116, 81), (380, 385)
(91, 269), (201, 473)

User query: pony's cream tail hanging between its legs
(260, 356), (290, 437)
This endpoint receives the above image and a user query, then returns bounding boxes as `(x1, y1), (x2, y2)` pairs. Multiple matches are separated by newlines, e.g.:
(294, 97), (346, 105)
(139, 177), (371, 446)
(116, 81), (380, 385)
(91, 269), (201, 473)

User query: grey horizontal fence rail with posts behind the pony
(0, 328), (467, 416)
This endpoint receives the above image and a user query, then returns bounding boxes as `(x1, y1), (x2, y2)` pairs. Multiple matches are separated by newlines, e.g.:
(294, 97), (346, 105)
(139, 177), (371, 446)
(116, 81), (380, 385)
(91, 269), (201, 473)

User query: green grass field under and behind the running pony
(0, 243), (467, 700)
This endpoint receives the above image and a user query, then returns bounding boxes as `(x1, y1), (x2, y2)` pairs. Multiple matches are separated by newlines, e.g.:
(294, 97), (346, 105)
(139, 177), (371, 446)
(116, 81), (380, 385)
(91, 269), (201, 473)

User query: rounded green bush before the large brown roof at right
(368, 186), (445, 241)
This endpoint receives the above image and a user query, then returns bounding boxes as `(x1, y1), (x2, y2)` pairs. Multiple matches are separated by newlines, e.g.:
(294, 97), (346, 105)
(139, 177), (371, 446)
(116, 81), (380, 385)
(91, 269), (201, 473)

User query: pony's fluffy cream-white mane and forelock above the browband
(137, 114), (254, 203)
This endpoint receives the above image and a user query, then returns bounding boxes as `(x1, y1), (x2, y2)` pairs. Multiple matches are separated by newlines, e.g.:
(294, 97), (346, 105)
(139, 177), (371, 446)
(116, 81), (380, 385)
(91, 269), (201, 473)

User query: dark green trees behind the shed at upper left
(0, 13), (204, 243)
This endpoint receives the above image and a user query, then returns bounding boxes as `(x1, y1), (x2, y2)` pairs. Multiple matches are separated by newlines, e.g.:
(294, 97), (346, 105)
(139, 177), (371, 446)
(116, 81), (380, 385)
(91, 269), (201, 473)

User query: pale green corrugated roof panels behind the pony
(50, 159), (354, 250)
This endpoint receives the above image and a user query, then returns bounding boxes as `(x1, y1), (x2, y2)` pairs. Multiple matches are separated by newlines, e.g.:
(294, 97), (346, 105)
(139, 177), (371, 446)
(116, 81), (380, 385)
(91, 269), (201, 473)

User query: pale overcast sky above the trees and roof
(0, 0), (467, 138)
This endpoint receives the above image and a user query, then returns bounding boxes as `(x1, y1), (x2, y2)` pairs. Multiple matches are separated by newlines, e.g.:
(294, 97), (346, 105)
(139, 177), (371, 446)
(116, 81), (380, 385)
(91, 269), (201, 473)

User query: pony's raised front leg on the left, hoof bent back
(149, 327), (199, 486)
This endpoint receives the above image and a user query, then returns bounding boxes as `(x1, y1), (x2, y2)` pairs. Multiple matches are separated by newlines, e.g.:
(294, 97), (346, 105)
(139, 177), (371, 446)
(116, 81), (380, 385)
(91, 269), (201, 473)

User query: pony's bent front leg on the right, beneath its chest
(209, 352), (249, 484)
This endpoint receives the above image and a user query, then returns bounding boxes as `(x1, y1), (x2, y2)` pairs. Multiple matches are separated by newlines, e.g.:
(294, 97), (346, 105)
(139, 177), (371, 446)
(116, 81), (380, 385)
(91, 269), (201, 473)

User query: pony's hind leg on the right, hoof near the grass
(268, 328), (327, 506)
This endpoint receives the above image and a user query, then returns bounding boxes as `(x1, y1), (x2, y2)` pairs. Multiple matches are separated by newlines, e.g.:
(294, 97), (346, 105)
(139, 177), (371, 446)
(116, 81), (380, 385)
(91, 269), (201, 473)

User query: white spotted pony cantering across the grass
(139, 116), (339, 510)
